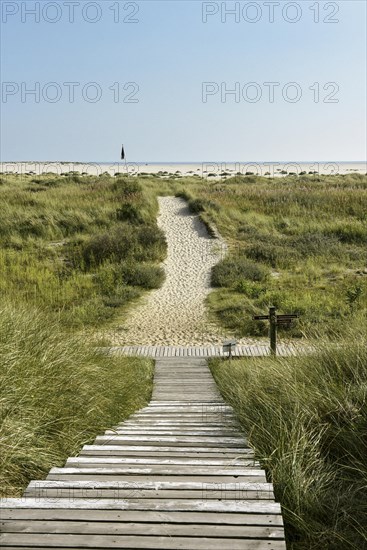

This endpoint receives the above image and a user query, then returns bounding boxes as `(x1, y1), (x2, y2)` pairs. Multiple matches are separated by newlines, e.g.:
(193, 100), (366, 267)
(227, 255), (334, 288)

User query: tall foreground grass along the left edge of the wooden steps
(0, 303), (153, 496)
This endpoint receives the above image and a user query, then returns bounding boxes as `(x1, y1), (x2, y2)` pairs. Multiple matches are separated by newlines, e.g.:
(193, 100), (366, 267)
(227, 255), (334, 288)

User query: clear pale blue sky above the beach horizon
(0, 0), (366, 162)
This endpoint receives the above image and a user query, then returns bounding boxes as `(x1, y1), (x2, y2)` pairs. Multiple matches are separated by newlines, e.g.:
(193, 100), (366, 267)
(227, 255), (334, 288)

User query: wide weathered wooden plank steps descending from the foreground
(0, 358), (286, 550)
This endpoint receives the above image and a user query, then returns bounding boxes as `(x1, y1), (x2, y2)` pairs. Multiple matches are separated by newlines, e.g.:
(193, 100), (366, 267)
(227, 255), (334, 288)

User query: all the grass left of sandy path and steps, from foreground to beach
(0, 174), (166, 496)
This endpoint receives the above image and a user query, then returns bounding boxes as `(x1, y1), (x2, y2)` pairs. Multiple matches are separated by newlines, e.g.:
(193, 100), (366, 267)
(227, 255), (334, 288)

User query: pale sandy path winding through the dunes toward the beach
(112, 197), (231, 346)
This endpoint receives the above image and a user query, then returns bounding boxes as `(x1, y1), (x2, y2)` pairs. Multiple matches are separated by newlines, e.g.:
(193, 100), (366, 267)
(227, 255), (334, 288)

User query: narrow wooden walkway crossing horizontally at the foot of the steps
(109, 343), (311, 358)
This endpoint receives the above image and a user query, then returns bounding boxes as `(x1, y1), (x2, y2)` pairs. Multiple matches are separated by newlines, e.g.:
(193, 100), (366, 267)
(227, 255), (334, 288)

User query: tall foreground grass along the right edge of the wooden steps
(211, 331), (367, 550)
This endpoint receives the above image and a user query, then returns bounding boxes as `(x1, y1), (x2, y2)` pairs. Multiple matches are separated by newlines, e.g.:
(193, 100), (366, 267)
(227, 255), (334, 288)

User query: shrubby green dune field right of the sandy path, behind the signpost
(172, 174), (367, 337)
